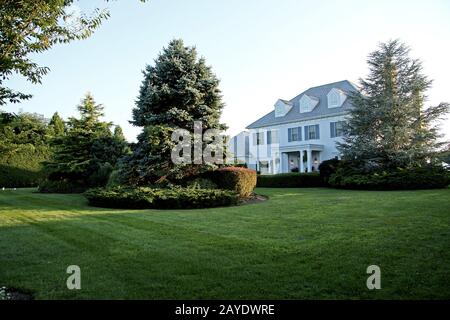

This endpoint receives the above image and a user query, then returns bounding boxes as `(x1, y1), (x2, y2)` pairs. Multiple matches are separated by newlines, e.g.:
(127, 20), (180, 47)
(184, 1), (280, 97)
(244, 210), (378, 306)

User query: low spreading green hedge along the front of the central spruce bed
(84, 187), (238, 209)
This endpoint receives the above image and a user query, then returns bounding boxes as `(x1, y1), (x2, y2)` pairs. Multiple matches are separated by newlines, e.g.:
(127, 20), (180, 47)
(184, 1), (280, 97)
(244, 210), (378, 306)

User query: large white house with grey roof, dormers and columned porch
(229, 80), (357, 174)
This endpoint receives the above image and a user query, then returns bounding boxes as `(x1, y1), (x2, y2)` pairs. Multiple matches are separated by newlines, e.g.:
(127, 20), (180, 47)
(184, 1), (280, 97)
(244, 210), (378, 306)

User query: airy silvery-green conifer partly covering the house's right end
(338, 40), (449, 168)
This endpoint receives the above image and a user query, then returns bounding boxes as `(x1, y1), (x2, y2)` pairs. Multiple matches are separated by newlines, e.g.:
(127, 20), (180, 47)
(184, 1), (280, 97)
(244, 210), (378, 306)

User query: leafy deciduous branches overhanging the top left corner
(0, 0), (145, 105)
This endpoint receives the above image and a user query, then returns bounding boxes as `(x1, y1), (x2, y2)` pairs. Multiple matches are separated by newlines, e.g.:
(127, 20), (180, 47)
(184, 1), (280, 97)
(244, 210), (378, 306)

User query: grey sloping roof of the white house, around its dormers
(247, 80), (358, 129)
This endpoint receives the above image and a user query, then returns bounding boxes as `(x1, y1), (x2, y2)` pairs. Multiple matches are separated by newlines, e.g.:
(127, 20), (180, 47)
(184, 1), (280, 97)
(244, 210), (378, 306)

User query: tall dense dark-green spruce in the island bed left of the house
(123, 40), (226, 184)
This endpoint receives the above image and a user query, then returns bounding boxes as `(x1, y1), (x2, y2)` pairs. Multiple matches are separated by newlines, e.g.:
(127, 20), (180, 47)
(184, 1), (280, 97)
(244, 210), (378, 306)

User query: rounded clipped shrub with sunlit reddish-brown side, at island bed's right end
(212, 167), (256, 199)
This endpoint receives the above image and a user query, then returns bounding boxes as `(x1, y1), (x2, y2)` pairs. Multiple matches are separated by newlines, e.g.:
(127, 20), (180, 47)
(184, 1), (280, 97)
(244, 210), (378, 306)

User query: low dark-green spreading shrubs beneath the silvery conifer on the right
(329, 166), (450, 190)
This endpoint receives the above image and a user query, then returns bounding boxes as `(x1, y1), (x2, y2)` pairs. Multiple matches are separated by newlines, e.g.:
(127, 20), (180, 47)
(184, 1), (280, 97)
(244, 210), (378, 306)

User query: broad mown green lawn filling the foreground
(0, 189), (450, 299)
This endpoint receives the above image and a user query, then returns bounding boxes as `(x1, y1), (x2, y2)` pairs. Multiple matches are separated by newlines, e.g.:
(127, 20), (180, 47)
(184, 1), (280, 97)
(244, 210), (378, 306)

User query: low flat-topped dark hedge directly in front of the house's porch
(257, 172), (323, 188)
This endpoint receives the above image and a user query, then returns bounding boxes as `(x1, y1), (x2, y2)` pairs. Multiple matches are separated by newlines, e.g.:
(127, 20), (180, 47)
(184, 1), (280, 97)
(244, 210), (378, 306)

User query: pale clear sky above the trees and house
(4, 0), (450, 140)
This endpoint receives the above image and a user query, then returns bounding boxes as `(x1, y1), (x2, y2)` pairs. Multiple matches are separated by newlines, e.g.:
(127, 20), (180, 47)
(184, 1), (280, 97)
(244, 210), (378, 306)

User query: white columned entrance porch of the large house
(280, 144), (323, 173)
